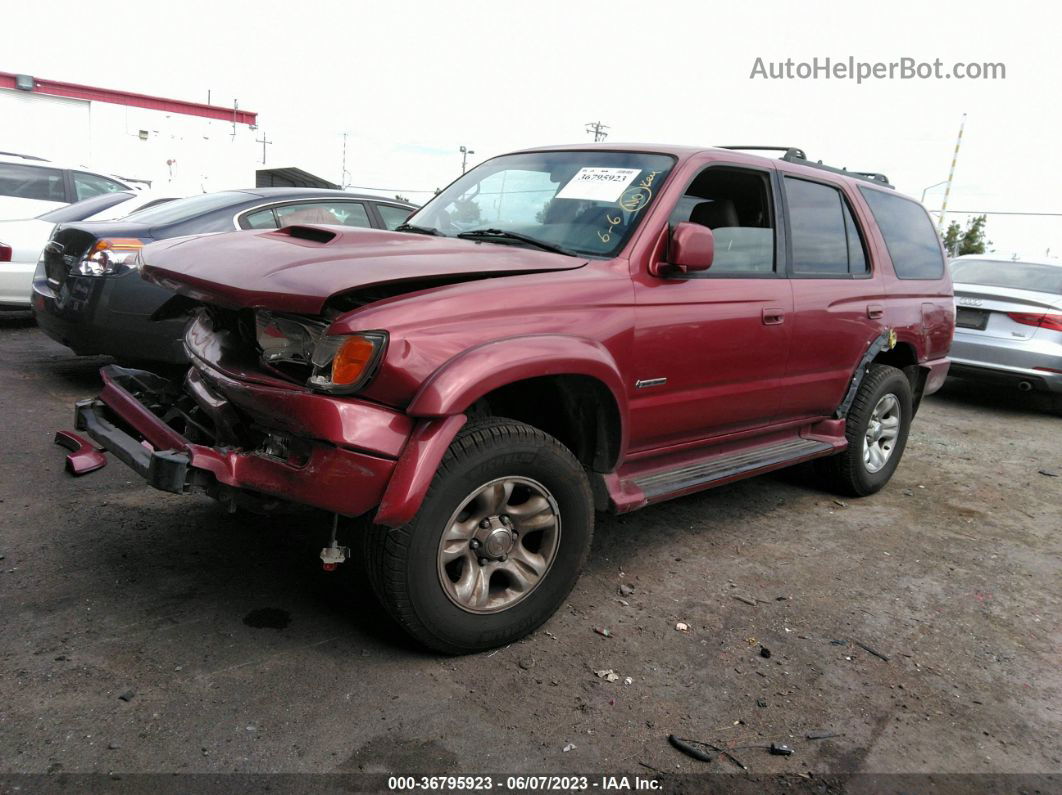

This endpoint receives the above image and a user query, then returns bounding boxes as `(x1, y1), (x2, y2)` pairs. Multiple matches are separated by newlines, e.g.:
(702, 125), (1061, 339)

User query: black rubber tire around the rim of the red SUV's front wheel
(363, 418), (594, 654)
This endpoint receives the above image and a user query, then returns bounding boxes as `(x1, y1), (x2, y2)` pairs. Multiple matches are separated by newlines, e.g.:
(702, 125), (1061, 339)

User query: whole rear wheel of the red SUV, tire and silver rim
(816, 364), (913, 497)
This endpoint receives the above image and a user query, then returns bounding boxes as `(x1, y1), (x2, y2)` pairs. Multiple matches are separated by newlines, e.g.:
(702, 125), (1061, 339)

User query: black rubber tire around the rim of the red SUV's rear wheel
(816, 364), (913, 497)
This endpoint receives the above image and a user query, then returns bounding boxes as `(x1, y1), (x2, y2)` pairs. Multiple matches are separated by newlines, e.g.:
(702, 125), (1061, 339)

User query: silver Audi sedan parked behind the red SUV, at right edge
(949, 255), (1062, 411)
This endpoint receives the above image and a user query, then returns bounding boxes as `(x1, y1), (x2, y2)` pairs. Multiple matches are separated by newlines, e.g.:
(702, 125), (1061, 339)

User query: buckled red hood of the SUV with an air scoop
(141, 226), (586, 314)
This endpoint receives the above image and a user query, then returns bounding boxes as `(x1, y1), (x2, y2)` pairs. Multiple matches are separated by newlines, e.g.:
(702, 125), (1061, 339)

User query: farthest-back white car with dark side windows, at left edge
(0, 153), (138, 219)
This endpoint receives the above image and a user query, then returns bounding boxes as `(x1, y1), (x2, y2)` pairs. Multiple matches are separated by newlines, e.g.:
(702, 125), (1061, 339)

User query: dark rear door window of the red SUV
(785, 176), (867, 277)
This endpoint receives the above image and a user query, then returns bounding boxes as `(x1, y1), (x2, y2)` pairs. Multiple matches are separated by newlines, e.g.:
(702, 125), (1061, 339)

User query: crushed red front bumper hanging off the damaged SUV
(67, 365), (398, 516)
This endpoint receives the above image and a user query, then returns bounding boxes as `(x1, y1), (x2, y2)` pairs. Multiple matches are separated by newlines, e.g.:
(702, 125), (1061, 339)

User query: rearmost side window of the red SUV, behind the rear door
(859, 187), (944, 279)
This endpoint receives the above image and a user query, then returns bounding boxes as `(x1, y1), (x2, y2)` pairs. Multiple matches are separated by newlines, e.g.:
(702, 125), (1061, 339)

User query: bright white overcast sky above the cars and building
(0, 0), (1062, 259)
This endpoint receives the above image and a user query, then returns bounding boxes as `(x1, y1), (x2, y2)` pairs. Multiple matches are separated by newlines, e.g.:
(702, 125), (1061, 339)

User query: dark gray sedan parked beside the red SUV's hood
(33, 188), (416, 364)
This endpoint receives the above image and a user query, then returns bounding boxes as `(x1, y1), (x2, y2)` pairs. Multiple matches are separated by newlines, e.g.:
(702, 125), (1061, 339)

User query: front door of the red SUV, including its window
(629, 163), (793, 453)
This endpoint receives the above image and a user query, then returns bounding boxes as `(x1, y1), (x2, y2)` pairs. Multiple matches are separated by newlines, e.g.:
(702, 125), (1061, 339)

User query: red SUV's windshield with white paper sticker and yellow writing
(399, 151), (674, 257)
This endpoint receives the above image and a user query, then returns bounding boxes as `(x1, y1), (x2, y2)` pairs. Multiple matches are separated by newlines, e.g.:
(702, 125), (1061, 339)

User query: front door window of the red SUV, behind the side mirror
(668, 166), (774, 278)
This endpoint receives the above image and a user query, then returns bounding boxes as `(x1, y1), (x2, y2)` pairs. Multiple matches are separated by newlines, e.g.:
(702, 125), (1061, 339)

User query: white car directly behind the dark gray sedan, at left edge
(0, 191), (176, 309)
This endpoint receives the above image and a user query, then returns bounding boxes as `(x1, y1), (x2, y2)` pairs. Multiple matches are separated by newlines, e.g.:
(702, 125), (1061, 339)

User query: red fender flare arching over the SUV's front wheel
(406, 334), (627, 418)
